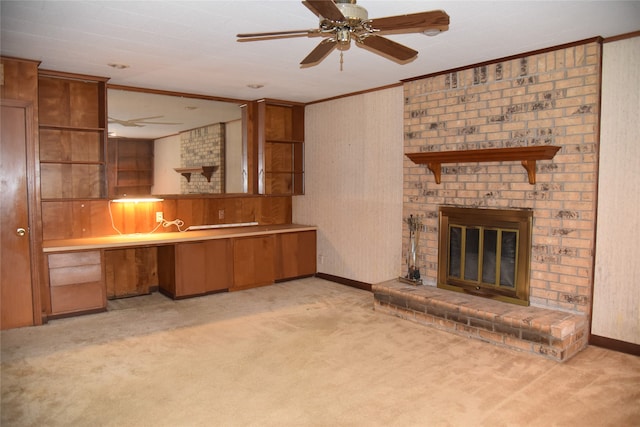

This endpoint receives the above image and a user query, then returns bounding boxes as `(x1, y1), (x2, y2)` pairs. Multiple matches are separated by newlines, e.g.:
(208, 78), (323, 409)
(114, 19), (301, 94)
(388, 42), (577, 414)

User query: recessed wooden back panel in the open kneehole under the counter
(104, 247), (158, 299)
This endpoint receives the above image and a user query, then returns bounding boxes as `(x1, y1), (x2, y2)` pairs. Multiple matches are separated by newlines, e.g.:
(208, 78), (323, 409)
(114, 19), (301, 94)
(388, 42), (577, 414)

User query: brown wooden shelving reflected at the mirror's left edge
(107, 138), (154, 198)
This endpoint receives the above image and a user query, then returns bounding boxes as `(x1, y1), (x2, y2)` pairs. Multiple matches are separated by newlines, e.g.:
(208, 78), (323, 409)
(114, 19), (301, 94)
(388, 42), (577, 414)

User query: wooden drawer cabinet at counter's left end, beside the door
(47, 251), (107, 317)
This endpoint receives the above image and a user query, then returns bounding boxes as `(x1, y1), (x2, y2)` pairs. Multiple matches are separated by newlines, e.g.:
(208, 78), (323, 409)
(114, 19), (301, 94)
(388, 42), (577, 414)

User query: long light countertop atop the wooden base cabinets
(42, 224), (318, 253)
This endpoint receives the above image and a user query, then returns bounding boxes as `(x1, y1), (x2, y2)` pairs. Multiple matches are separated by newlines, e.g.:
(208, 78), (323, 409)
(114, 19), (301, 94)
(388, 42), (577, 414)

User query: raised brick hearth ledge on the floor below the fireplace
(372, 280), (588, 362)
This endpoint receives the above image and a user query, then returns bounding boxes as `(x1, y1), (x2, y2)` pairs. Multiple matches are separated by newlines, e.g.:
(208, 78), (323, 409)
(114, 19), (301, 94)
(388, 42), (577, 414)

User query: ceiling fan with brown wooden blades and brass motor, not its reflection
(237, 0), (449, 68)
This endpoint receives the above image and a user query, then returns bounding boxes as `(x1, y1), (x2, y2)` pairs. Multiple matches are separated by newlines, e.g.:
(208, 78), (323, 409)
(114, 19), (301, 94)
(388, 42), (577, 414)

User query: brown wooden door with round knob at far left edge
(0, 101), (33, 329)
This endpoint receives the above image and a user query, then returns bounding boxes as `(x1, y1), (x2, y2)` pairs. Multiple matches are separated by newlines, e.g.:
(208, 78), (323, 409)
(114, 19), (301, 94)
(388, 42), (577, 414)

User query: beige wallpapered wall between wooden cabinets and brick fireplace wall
(293, 86), (404, 283)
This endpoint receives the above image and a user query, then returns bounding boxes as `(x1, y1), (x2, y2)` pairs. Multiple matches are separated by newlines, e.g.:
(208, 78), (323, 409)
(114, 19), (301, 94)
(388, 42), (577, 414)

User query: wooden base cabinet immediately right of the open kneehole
(158, 239), (233, 298)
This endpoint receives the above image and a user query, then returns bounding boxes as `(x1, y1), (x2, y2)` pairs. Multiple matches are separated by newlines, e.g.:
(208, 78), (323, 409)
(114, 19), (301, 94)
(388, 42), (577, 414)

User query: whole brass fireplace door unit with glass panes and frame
(438, 206), (533, 305)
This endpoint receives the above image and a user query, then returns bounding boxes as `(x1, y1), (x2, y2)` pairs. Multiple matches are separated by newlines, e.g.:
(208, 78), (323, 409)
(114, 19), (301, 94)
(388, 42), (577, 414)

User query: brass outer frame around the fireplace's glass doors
(438, 206), (533, 306)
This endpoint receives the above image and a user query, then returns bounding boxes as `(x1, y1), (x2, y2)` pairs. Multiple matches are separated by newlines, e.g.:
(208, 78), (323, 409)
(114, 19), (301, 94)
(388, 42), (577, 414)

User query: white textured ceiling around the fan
(0, 0), (640, 137)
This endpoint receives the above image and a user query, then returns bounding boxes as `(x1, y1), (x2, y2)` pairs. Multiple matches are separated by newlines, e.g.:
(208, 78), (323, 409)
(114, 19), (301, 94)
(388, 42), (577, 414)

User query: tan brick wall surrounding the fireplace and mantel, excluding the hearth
(402, 42), (601, 313)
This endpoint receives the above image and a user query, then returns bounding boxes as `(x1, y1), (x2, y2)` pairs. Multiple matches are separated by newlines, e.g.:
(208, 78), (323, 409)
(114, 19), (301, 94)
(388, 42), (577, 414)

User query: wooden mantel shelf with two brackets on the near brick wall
(406, 145), (560, 184)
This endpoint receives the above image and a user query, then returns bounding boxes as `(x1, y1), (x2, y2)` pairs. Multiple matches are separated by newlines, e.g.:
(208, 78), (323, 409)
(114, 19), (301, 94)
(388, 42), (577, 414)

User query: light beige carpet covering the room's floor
(1, 278), (640, 427)
